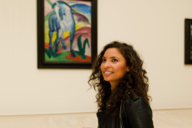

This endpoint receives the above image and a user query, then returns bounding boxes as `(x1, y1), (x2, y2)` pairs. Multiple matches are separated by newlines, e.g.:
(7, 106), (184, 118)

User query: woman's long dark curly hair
(88, 41), (151, 115)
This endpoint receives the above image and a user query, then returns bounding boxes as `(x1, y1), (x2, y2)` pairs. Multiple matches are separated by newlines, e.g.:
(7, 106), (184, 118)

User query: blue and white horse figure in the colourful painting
(47, 0), (76, 58)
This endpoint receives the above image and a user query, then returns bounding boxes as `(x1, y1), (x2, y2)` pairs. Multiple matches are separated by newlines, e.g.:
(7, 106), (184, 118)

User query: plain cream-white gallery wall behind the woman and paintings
(0, 0), (192, 115)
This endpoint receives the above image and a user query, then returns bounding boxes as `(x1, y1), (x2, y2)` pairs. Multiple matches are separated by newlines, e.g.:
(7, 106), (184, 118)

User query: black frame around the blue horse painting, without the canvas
(37, 0), (97, 69)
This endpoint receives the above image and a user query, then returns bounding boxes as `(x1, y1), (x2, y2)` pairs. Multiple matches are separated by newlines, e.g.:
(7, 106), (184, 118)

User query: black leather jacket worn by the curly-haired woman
(97, 96), (154, 128)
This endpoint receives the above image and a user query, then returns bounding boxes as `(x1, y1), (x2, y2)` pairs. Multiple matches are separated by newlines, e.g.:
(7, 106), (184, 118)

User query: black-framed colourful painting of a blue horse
(37, 0), (97, 69)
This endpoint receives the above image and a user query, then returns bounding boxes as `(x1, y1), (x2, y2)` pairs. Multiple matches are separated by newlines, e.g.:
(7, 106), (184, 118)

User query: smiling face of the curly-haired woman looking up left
(100, 48), (129, 85)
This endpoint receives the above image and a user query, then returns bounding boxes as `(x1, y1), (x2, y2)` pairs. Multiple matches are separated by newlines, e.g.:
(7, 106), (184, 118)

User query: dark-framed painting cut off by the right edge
(185, 19), (192, 64)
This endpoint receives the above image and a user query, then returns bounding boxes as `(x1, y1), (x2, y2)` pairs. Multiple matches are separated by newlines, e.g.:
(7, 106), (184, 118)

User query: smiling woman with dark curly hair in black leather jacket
(88, 41), (153, 128)
